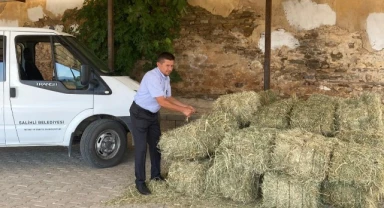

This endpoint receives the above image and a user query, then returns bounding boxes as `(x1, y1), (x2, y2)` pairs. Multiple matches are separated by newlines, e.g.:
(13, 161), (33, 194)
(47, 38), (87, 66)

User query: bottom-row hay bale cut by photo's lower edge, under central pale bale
(262, 173), (320, 208)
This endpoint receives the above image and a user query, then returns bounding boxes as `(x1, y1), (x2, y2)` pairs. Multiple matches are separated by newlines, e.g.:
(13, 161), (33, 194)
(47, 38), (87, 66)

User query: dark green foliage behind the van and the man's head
(68, 0), (186, 81)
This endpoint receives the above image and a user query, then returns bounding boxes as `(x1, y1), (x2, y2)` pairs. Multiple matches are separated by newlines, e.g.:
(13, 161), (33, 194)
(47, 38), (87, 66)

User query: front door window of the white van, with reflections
(16, 36), (86, 90)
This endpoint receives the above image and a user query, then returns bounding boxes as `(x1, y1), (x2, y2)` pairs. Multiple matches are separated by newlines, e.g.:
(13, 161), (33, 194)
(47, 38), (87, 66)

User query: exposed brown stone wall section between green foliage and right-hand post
(174, 7), (263, 96)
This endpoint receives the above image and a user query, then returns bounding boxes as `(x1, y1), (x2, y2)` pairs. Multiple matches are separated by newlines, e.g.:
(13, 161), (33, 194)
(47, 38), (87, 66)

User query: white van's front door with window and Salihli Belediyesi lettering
(7, 32), (93, 145)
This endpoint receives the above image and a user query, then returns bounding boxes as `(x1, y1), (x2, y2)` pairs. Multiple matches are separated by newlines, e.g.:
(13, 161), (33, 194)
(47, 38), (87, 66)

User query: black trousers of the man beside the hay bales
(130, 102), (161, 184)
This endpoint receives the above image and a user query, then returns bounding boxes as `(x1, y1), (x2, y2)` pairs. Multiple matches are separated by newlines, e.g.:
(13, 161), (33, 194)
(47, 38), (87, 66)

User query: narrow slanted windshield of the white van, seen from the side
(61, 36), (111, 74)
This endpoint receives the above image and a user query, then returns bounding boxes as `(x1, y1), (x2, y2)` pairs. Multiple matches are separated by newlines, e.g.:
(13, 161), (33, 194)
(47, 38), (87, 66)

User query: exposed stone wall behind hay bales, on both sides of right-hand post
(174, 1), (384, 99)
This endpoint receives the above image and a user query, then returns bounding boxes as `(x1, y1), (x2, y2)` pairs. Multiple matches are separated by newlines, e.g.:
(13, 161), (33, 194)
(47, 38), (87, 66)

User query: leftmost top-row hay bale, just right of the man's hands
(212, 91), (261, 126)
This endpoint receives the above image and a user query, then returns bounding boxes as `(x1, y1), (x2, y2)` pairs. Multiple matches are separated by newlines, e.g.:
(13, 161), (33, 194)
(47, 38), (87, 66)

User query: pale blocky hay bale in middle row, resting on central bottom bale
(272, 129), (334, 181)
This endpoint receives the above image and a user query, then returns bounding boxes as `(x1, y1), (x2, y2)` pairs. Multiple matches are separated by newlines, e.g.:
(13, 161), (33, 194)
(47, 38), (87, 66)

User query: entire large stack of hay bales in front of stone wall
(154, 92), (384, 208)
